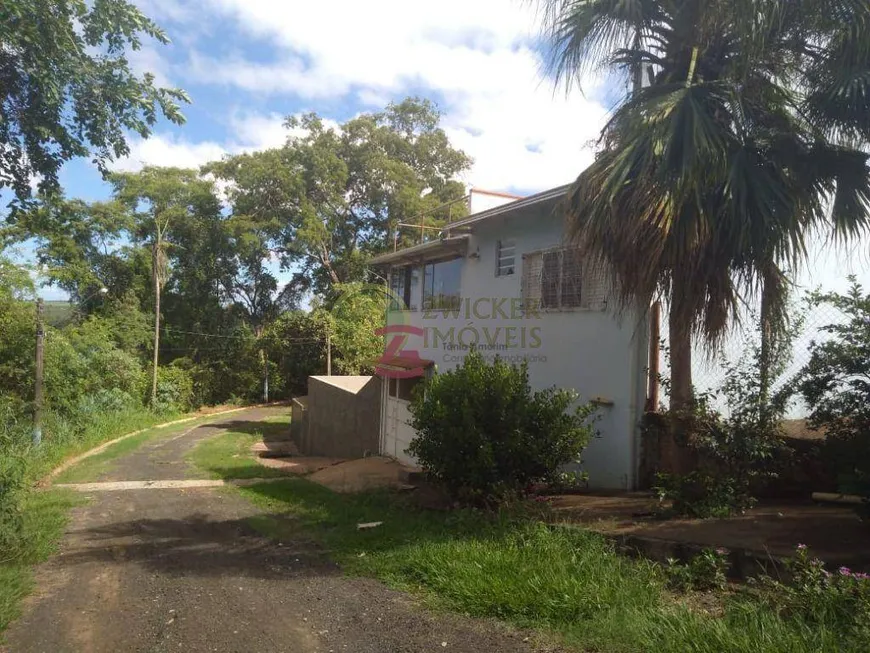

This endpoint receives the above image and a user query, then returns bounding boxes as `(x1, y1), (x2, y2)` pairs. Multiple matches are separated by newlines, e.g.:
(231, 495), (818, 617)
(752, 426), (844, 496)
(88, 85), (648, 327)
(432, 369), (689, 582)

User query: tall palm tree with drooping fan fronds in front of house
(542, 0), (870, 410)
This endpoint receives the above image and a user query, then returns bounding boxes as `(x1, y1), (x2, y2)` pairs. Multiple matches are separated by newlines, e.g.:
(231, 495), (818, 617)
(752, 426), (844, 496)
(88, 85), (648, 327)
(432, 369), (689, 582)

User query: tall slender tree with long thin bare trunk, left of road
(110, 167), (220, 406)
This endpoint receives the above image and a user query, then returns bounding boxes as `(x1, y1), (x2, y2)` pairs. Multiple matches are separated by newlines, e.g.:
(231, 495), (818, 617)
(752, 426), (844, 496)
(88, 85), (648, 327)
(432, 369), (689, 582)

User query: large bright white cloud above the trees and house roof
(179, 0), (606, 190)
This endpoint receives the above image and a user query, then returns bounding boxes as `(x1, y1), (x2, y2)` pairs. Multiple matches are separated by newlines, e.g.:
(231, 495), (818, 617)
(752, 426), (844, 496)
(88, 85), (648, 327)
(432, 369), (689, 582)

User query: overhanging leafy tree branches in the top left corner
(0, 0), (189, 202)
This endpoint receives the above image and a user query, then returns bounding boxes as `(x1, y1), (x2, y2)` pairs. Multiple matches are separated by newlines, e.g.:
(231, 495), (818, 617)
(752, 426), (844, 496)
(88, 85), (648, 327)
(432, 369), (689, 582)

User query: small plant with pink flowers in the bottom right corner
(760, 544), (870, 639)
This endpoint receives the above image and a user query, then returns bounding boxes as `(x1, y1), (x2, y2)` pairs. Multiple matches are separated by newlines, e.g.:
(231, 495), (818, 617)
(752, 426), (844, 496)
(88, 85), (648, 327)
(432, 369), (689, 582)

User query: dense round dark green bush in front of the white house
(408, 352), (594, 504)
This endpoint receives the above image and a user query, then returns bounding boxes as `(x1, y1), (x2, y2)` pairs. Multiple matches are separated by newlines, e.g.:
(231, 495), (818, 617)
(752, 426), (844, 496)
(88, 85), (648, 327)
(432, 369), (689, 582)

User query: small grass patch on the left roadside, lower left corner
(0, 490), (81, 632)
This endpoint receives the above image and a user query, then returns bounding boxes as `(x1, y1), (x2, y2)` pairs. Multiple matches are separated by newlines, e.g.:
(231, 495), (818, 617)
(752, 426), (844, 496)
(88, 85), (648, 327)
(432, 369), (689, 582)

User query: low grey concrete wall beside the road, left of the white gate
(297, 376), (381, 458)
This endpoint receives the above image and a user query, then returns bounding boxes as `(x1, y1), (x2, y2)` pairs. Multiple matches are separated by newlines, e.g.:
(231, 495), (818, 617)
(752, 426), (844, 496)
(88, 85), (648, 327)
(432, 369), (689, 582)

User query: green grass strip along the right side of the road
(192, 434), (870, 653)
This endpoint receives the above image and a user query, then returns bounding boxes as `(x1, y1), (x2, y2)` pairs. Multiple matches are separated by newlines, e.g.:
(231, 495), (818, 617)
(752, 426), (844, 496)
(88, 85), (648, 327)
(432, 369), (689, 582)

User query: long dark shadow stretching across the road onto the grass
(64, 479), (490, 578)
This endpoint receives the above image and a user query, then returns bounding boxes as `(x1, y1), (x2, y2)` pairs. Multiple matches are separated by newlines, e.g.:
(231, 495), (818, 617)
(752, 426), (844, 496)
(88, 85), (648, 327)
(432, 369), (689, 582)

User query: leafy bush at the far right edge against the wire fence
(797, 277), (870, 499)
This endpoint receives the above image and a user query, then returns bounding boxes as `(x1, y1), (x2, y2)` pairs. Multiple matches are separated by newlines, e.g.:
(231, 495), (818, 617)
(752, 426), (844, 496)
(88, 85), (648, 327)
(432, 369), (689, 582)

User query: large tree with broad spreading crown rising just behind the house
(206, 99), (471, 294)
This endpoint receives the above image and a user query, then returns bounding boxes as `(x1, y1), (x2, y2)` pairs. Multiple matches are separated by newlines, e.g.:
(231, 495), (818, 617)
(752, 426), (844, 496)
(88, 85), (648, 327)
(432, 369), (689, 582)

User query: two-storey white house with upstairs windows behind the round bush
(372, 187), (649, 489)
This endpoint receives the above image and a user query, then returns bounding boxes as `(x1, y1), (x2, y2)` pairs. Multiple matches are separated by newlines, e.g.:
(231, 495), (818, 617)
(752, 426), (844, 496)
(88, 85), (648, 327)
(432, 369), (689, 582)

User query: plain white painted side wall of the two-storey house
(385, 205), (648, 489)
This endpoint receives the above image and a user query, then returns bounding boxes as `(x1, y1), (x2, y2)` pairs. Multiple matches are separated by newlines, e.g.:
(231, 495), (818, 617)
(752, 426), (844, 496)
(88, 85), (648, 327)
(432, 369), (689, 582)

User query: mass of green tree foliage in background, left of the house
(0, 100), (468, 412)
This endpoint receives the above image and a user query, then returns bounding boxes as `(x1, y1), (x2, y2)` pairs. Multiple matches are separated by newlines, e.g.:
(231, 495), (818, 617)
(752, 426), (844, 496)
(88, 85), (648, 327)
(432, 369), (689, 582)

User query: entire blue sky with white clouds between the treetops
(24, 0), (619, 298)
